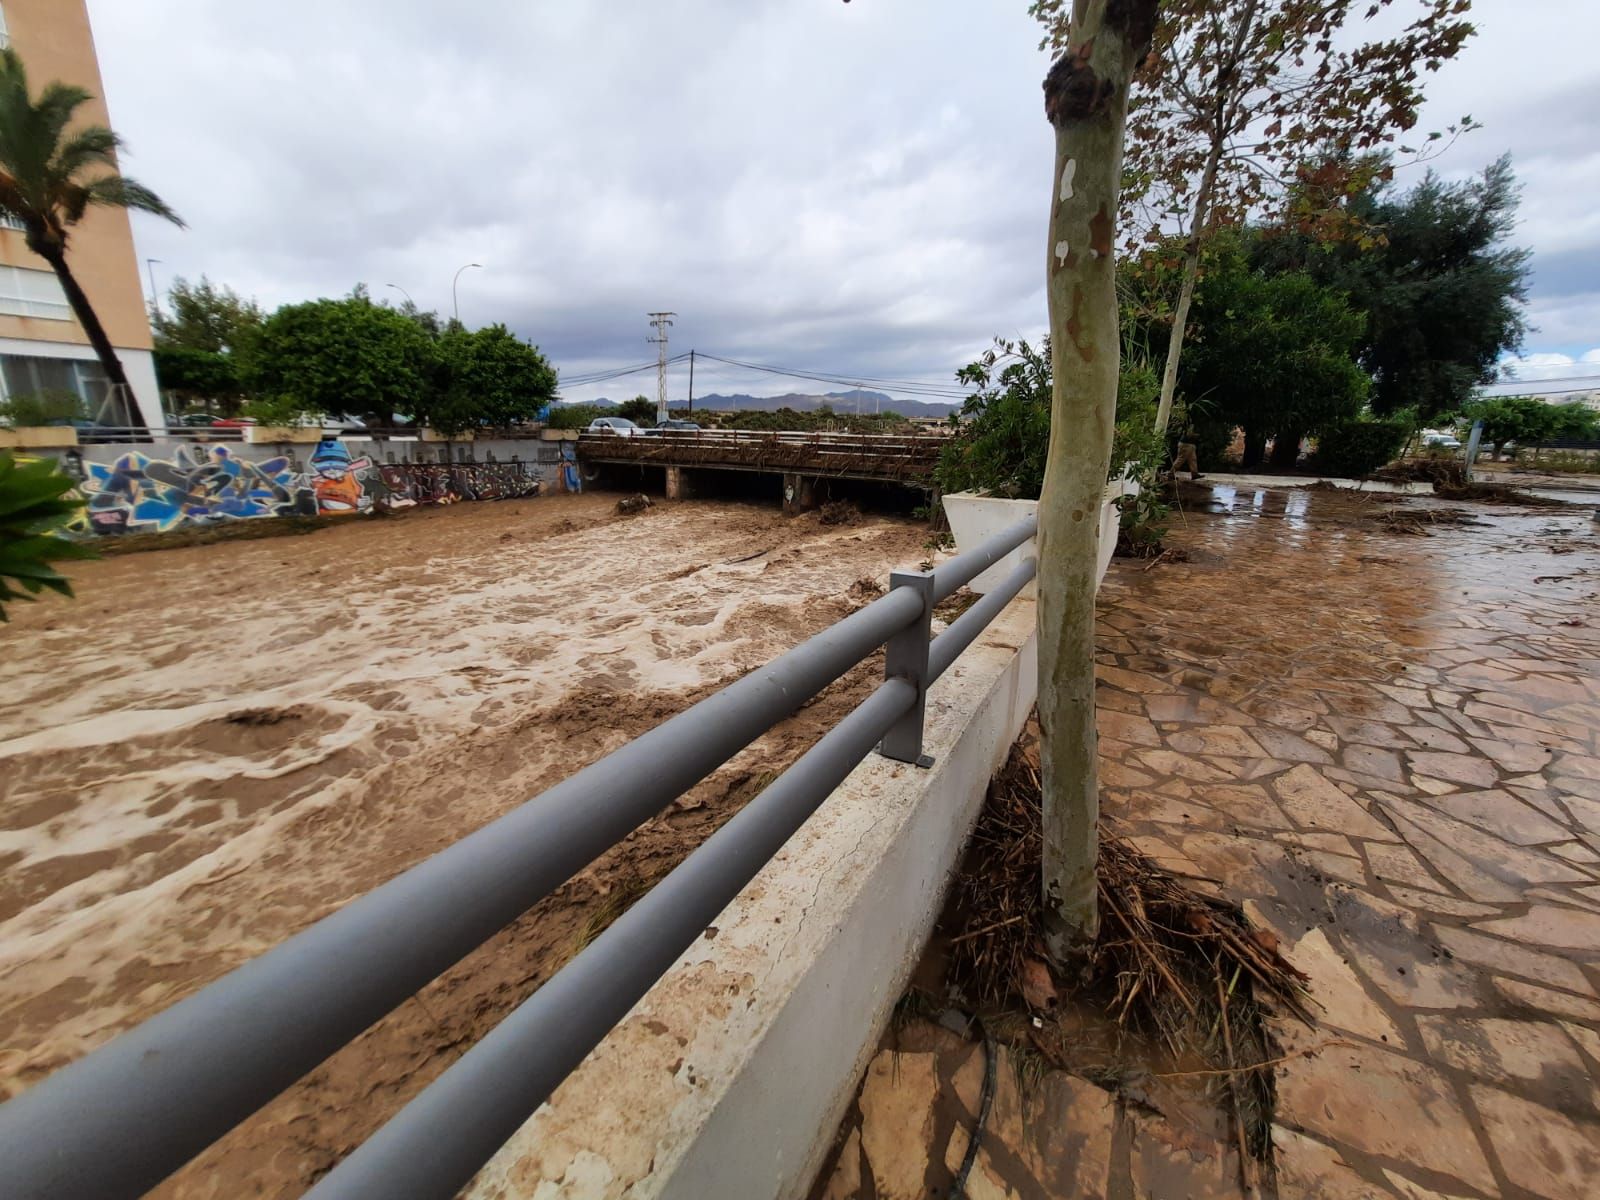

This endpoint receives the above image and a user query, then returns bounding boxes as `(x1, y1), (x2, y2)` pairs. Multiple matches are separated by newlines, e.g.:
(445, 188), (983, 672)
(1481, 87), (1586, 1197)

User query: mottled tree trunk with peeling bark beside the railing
(1038, 0), (1157, 963)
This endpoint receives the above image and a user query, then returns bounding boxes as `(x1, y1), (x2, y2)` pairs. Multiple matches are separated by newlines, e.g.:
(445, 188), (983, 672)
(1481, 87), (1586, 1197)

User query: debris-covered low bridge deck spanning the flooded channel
(578, 429), (947, 486)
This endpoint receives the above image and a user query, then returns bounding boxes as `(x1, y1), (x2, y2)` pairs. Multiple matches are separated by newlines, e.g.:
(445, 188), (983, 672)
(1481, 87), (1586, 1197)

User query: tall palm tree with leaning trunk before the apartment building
(0, 48), (182, 427)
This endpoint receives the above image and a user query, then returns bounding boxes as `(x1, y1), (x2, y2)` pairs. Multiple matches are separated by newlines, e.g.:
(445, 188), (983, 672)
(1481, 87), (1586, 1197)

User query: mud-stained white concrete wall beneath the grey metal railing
(466, 600), (1037, 1200)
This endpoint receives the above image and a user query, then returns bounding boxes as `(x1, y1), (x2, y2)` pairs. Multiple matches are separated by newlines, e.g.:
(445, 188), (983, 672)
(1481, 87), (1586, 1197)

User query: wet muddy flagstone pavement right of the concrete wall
(818, 488), (1600, 1200)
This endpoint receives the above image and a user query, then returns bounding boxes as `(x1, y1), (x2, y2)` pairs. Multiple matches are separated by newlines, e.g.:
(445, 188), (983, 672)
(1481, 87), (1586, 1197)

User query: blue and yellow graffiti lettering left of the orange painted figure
(83, 445), (317, 533)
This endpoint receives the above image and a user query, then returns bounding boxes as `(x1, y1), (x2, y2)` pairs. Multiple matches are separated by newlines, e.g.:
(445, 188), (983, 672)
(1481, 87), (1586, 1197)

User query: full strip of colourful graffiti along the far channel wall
(64, 438), (539, 534)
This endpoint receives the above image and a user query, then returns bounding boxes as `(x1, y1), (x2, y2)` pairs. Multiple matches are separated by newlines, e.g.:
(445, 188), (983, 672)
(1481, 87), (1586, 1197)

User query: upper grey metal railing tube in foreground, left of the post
(0, 589), (923, 1200)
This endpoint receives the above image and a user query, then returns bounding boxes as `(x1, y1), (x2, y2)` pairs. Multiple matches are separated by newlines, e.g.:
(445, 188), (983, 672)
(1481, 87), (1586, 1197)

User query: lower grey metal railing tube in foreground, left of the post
(306, 678), (917, 1200)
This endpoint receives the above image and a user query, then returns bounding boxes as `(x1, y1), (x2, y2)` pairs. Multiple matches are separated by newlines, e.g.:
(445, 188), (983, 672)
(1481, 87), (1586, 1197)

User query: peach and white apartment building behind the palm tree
(0, 0), (163, 426)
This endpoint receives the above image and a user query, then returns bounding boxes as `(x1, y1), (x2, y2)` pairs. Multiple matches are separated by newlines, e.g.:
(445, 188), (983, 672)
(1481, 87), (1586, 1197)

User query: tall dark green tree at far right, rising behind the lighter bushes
(1261, 157), (1530, 421)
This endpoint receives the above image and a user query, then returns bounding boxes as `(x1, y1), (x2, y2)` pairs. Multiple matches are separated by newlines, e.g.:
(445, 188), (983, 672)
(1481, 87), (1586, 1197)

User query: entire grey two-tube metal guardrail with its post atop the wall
(0, 517), (1037, 1200)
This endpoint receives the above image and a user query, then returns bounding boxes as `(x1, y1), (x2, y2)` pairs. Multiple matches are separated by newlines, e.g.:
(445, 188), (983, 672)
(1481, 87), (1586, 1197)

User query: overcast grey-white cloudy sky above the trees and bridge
(90, 0), (1600, 406)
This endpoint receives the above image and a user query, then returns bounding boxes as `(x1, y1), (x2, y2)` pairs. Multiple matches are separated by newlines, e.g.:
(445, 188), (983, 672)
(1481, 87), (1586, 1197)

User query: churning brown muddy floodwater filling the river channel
(0, 496), (928, 1197)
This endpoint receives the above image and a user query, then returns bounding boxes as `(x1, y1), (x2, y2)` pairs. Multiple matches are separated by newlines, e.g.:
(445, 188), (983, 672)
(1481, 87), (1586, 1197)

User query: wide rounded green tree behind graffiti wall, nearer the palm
(243, 294), (440, 427)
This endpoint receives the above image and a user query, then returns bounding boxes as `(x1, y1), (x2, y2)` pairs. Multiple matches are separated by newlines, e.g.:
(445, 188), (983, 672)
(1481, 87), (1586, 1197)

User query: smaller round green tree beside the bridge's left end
(414, 325), (555, 434)
